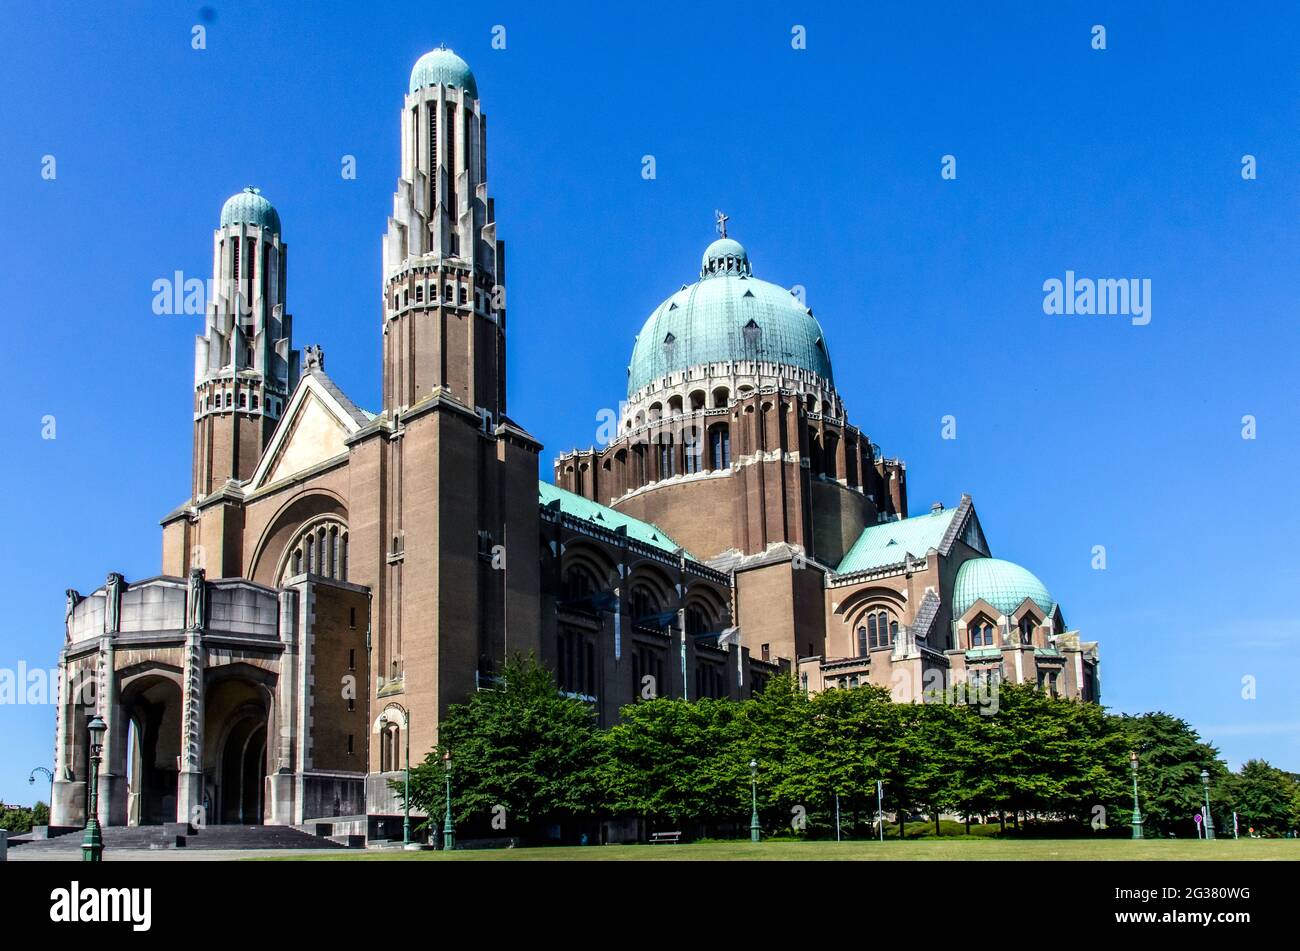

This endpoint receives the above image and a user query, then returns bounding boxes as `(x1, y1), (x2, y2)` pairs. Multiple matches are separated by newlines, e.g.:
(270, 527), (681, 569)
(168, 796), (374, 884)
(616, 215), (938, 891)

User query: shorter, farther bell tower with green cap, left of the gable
(192, 187), (298, 503)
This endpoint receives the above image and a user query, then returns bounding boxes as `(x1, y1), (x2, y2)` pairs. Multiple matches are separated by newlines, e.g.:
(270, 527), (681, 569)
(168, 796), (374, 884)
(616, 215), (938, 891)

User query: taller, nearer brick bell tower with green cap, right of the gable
(348, 47), (542, 815)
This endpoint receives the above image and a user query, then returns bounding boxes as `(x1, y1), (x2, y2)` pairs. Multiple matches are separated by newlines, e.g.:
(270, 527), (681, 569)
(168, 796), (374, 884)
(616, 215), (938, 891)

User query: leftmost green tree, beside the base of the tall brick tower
(394, 657), (599, 835)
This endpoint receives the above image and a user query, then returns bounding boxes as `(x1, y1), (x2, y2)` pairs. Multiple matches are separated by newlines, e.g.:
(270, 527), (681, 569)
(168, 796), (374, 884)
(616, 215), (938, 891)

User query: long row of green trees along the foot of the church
(411, 660), (1300, 838)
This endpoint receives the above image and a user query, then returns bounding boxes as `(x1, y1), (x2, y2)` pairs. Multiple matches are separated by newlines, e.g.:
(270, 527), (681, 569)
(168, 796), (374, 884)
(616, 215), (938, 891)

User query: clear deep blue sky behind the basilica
(0, 0), (1300, 802)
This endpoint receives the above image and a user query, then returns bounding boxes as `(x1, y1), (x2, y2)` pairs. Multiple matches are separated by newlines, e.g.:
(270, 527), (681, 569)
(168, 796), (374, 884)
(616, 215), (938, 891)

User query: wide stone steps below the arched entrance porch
(9, 824), (347, 855)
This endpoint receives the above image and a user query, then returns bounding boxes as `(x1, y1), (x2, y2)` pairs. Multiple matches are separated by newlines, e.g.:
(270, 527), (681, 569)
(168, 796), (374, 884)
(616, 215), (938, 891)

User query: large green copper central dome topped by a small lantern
(628, 238), (833, 398)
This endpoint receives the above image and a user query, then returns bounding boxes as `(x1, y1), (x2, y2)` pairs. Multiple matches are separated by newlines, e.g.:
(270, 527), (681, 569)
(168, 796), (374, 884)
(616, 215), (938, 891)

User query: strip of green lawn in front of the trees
(286, 835), (1300, 861)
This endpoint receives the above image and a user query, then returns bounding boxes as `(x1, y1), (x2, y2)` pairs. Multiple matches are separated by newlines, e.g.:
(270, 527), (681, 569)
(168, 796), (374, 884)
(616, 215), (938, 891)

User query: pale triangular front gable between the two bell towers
(247, 369), (372, 490)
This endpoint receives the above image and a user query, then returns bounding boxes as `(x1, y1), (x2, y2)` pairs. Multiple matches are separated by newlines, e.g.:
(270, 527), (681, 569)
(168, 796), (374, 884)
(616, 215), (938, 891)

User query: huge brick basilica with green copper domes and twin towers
(51, 48), (1100, 839)
